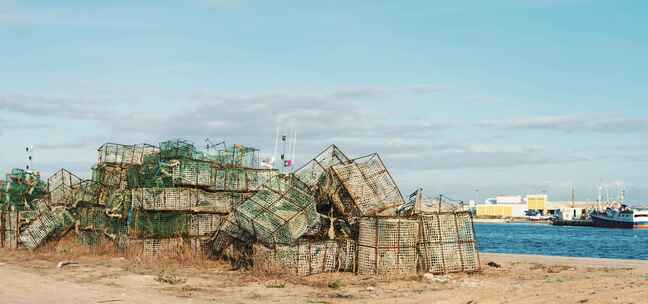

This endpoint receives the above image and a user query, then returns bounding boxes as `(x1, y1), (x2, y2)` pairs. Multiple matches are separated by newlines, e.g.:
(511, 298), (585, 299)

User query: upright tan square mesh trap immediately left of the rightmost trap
(358, 217), (419, 275)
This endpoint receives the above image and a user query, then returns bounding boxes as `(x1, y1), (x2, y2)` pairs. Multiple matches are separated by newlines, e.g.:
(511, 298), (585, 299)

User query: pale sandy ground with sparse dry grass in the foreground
(0, 250), (648, 304)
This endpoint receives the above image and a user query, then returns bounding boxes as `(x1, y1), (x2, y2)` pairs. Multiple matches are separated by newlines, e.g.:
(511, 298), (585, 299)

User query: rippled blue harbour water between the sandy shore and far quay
(475, 223), (648, 260)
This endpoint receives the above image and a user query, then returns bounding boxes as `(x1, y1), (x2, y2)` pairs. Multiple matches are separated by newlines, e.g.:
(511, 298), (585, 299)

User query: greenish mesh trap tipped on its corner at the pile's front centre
(234, 177), (319, 247)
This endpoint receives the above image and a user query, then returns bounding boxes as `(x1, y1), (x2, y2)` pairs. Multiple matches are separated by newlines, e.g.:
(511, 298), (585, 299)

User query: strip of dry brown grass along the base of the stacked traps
(0, 233), (430, 292)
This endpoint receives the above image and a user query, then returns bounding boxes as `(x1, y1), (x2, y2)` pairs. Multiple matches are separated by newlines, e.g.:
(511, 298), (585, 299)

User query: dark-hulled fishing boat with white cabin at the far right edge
(590, 205), (648, 229)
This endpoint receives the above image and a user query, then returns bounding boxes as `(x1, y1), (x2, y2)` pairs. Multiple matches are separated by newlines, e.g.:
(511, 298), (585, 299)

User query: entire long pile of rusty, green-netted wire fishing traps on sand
(0, 140), (480, 275)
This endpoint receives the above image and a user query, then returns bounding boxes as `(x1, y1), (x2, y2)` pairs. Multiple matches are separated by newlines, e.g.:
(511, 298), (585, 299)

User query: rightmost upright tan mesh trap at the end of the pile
(418, 212), (480, 273)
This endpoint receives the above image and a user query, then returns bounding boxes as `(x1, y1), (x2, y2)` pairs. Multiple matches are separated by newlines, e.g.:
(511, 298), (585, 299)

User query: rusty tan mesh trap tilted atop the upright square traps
(332, 153), (405, 216)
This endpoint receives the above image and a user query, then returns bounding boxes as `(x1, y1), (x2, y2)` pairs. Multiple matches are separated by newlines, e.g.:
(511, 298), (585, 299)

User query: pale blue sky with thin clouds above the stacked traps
(0, 0), (648, 203)
